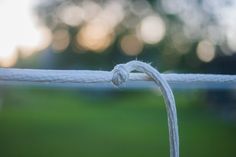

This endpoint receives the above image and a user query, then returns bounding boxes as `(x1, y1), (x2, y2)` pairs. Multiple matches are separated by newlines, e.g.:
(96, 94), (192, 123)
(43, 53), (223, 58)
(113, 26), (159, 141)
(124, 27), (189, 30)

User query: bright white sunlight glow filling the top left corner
(0, 0), (50, 66)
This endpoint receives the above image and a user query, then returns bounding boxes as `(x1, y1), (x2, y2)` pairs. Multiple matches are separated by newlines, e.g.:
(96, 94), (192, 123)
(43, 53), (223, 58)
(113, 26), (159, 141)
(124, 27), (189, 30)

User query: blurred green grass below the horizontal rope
(0, 88), (236, 157)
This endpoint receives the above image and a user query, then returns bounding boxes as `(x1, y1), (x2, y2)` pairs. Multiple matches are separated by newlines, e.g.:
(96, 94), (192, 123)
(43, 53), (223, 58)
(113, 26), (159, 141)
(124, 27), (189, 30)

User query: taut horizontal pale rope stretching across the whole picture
(0, 68), (236, 88)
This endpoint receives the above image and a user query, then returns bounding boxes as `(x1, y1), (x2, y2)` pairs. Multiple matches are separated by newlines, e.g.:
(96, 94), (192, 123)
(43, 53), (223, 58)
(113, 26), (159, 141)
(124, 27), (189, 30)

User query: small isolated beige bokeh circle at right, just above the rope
(197, 40), (215, 62)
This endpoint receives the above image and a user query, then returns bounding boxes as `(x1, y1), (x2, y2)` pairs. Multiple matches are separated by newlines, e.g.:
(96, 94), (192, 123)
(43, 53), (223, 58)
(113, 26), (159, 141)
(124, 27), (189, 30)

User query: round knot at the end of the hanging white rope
(112, 64), (129, 87)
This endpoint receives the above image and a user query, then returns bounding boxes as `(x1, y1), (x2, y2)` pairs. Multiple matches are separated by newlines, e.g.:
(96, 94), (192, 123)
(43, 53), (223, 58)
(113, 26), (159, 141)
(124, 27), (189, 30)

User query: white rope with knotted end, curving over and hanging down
(112, 61), (179, 157)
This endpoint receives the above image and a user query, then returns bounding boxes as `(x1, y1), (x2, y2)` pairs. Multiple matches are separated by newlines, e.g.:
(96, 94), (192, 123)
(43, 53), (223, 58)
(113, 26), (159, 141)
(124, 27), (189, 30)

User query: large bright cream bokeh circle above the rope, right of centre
(139, 15), (166, 44)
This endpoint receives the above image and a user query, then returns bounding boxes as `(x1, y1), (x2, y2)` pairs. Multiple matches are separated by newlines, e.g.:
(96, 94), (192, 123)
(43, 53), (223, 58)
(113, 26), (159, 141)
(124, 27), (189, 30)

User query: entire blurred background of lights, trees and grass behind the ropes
(0, 0), (236, 157)
